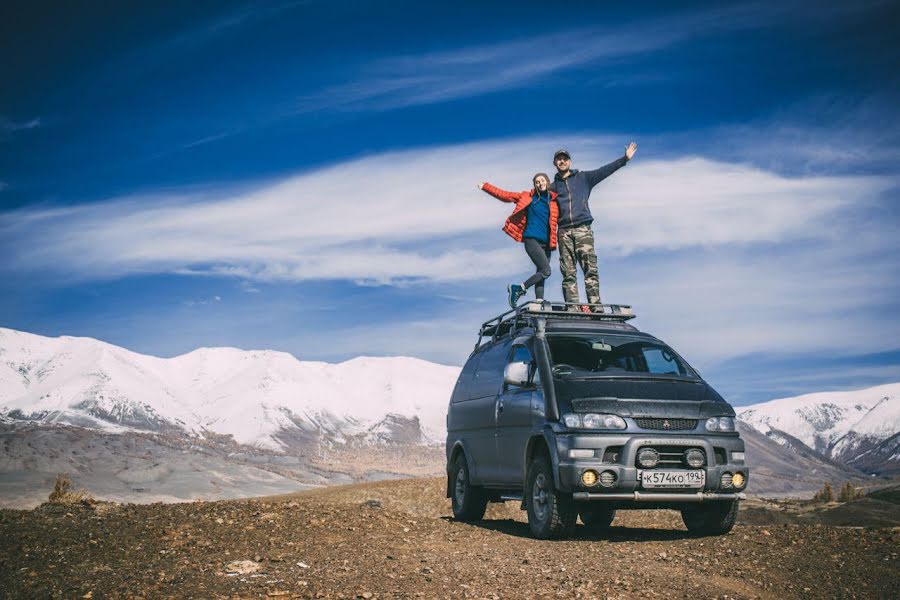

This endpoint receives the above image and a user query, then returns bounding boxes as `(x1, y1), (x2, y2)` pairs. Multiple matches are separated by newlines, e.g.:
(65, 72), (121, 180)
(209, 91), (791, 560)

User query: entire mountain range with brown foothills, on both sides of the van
(0, 328), (900, 505)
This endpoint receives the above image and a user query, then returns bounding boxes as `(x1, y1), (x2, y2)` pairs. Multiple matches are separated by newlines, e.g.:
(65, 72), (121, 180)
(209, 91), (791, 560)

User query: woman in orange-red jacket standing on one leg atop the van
(478, 173), (559, 308)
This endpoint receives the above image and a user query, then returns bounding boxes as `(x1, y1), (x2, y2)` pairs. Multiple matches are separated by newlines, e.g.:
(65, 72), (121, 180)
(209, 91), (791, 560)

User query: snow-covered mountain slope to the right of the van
(736, 383), (900, 473)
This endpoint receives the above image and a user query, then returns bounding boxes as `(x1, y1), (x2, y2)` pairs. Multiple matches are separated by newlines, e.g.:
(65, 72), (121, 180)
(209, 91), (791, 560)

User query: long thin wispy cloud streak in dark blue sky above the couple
(296, 2), (884, 113)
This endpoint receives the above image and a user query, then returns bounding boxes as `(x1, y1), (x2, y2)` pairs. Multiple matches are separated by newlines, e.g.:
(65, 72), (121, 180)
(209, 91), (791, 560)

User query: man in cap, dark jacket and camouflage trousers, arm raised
(550, 142), (637, 312)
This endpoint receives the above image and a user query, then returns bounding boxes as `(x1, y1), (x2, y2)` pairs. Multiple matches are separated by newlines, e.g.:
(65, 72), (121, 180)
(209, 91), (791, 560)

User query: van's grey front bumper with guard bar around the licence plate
(557, 434), (750, 503)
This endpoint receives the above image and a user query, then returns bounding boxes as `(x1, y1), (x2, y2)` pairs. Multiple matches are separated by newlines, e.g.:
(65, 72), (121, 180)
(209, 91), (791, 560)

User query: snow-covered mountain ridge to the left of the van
(0, 328), (459, 451)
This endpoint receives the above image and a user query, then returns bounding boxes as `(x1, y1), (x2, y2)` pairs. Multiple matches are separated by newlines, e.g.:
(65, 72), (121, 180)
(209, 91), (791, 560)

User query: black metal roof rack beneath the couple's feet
(475, 300), (636, 348)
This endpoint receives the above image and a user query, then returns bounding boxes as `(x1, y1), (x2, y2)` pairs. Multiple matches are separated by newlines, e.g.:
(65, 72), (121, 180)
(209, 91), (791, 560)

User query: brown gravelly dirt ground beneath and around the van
(0, 479), (900, 599)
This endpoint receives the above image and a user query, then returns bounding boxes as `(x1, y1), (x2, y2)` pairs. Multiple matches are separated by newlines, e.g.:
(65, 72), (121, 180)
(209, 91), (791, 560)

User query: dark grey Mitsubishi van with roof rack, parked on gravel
(447, 301), (749, 539)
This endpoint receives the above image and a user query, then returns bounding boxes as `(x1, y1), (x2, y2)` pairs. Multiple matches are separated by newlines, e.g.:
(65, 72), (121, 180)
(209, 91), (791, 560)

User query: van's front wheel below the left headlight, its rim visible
(525, 456), (578, 540)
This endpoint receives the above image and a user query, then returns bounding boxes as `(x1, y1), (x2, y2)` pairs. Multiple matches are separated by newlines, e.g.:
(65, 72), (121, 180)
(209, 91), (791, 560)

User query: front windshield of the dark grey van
(547, 333), (697, 379)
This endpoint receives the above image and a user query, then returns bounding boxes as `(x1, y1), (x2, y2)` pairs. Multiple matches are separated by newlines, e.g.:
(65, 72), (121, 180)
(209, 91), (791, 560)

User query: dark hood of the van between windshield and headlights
(554, 378), (734, 419)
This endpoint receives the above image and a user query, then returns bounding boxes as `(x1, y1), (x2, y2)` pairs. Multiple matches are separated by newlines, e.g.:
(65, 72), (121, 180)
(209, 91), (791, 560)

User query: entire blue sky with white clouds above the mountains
(0, 1), (900, 404)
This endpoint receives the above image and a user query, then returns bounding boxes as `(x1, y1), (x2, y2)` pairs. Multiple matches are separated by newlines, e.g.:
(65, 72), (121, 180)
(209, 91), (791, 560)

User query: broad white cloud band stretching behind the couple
(0, 138), (895, 283)
